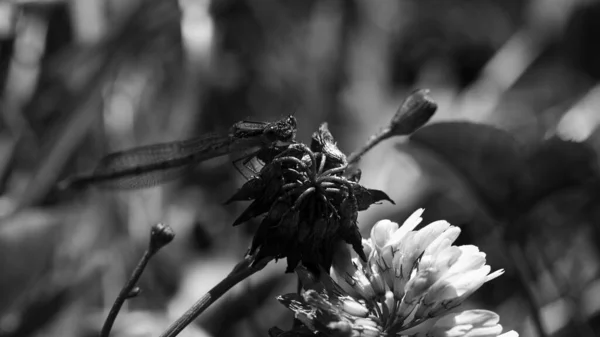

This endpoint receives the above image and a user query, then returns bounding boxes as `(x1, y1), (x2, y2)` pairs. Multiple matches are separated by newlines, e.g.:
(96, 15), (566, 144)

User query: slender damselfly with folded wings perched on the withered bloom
(60, 116), (296, 189)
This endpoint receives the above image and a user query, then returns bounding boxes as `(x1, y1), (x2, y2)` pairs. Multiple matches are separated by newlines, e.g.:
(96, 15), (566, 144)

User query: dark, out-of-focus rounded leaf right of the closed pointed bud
(410, 122), (527, 212)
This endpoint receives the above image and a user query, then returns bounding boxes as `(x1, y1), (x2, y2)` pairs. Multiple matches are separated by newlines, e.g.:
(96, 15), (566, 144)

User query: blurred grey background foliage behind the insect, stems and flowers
(0, 0), (600, 336)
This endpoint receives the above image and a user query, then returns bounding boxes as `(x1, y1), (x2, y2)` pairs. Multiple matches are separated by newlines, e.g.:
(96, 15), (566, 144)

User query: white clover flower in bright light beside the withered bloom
(279, 209), (518, 337)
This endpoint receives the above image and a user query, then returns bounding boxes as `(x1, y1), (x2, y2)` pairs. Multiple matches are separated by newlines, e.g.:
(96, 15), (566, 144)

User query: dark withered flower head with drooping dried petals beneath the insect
(228, 124), (393, 272)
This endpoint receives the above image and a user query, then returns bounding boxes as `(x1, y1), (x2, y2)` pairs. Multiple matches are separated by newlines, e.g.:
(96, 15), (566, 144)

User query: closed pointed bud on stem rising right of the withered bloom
(389, 89), (437, 136)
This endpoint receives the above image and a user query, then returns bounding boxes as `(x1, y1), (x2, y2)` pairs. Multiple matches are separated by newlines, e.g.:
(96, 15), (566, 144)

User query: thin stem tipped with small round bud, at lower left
(100, 224), (175, 337)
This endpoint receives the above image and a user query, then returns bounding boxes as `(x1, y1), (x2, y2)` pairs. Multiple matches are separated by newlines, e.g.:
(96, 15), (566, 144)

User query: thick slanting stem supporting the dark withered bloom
(160, 256), (272, 337)
